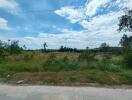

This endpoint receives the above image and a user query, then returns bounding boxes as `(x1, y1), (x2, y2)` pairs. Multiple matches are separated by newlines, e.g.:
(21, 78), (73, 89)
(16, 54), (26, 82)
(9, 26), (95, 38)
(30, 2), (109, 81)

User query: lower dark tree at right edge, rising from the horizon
(119, 34), (132, 51)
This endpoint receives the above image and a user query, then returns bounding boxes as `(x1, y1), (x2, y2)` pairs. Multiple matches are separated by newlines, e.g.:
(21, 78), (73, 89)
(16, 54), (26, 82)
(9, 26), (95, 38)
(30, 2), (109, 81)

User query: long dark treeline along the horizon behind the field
(0, 34), (132, 55)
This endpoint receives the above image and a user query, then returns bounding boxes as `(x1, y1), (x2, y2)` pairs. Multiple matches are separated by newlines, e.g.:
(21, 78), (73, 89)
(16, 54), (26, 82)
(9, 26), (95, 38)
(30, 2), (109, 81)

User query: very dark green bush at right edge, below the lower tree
(123, 52), (132, 69)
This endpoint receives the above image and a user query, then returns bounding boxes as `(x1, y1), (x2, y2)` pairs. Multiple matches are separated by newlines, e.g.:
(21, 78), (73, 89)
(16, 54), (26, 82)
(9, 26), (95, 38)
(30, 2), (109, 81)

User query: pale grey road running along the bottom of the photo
(0, 85), (132, 100)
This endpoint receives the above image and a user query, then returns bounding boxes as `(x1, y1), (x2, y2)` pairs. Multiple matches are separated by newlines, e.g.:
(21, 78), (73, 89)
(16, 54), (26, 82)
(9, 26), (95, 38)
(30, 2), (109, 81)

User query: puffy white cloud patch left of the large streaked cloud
(55, 7), (85, 23)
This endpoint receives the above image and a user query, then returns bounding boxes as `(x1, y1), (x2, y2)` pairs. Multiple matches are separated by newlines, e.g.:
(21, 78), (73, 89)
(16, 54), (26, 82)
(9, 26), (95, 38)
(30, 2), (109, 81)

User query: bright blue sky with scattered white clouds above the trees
(0, 0), (132, 49)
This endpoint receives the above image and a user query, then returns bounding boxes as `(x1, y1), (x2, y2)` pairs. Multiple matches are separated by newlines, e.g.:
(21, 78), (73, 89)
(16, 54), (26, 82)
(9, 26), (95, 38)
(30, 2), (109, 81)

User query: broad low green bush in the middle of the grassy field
(43, 57), (83, 72)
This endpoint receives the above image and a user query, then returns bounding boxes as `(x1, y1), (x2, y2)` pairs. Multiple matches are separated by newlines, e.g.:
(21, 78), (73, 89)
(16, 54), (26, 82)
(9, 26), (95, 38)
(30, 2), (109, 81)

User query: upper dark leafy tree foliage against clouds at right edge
(119, 10), (132, 31)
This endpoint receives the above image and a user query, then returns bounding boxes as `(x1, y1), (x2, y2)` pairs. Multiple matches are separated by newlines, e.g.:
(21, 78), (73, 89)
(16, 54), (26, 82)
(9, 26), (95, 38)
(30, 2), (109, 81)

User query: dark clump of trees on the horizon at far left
(0, 40), (23, 56)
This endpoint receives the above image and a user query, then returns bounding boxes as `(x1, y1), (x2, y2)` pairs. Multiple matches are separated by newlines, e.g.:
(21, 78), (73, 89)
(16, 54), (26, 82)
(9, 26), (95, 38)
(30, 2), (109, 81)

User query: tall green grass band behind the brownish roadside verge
(0, 52), (125, 72)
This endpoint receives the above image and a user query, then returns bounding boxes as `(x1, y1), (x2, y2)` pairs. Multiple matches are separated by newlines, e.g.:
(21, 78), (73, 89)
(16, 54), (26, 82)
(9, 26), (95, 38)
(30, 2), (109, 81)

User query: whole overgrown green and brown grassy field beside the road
(0, 52), (132, 85)
